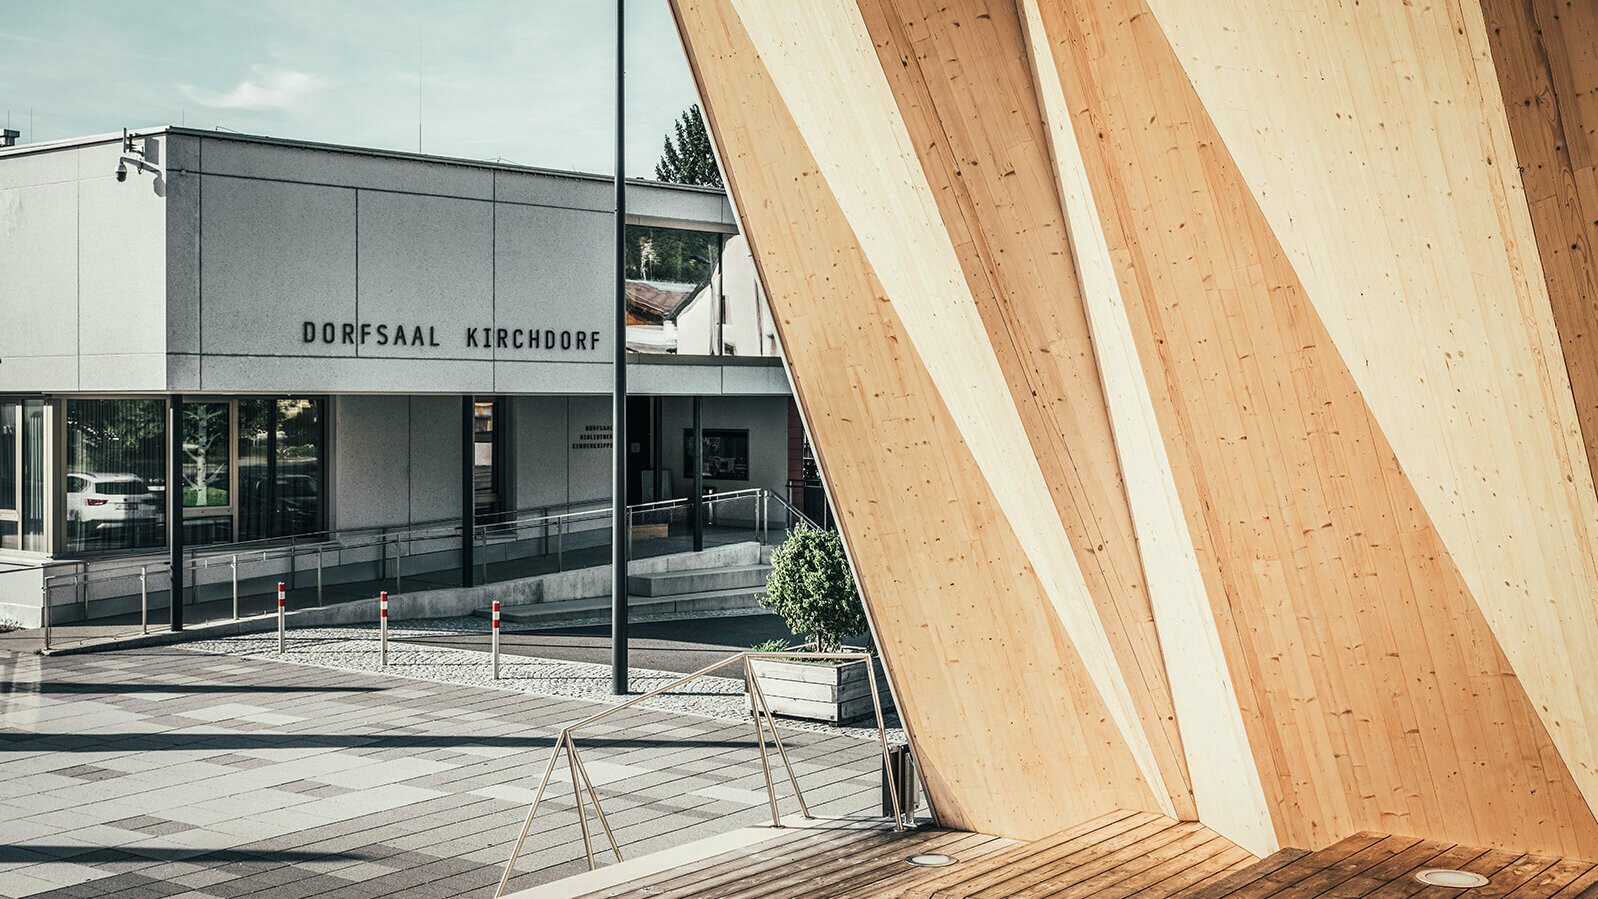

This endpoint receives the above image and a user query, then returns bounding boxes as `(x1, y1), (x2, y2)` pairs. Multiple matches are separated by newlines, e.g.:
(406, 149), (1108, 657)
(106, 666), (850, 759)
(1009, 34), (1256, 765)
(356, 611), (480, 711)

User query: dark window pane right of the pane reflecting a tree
(238, 398), (324, 540)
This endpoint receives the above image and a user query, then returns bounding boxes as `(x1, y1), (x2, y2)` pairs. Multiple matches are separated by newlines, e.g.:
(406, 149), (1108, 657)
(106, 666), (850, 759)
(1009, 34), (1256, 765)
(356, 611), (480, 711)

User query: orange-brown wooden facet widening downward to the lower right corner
(1042, 0), (1598, 856)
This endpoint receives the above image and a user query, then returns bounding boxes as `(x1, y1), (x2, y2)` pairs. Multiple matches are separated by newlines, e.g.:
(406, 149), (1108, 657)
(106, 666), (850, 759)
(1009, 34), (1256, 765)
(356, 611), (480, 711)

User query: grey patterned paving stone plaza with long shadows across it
(0, 637), (880, 899)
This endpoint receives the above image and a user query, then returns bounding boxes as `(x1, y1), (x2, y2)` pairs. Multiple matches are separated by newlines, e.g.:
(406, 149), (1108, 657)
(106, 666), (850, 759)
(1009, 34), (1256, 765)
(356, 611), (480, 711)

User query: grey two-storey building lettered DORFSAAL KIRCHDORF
(0, 128), (802, 624)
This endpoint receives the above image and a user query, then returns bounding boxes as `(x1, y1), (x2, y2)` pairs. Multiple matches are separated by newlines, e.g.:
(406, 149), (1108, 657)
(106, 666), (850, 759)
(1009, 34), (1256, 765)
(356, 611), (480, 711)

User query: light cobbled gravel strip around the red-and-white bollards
(181, 615), (906, 743)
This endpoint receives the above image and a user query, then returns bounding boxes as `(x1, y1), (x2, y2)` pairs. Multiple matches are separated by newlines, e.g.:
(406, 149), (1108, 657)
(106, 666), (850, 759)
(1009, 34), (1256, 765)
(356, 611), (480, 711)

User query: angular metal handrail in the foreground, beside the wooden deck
(494, 644), (904, 897)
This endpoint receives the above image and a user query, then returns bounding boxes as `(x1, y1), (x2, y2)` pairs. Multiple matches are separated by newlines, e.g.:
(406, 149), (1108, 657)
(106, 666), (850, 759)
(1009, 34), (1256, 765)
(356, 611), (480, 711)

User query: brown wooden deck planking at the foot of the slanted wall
(565, 811), (1598, 899)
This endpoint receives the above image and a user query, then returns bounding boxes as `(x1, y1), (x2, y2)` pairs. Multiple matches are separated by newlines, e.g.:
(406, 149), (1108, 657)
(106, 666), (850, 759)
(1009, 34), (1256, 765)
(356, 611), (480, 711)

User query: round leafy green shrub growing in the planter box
(761, 525), (866, 653)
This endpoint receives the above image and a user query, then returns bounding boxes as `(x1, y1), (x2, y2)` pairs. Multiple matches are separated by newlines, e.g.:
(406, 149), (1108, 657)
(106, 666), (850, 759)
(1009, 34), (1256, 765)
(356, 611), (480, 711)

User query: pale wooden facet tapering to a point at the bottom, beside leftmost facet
(732, 0), (1186, 814)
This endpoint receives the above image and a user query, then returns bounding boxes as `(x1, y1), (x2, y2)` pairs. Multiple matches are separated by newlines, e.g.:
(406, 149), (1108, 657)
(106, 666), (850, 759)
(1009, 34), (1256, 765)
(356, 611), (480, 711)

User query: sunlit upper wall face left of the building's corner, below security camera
(0, 136), (168, 391)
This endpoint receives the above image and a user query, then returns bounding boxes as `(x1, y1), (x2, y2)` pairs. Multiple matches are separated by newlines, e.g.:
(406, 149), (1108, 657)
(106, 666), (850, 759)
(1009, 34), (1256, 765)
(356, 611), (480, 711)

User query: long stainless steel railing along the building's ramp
(40, 487), (815, 648)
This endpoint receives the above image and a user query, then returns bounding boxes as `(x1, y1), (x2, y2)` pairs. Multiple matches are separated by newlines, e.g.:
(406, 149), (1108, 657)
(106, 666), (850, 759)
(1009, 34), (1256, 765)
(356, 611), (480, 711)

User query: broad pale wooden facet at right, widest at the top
(1149, 0), (1598, 802)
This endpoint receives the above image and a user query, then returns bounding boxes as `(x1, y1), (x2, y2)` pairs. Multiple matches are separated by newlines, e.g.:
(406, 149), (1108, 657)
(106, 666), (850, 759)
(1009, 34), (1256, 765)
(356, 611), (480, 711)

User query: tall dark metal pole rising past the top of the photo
(610, 0), (630, 699)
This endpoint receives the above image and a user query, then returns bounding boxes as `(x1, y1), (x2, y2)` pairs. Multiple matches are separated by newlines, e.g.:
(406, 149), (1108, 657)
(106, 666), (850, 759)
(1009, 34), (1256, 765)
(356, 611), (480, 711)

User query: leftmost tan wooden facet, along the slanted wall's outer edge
(674, 2), (1160, 837)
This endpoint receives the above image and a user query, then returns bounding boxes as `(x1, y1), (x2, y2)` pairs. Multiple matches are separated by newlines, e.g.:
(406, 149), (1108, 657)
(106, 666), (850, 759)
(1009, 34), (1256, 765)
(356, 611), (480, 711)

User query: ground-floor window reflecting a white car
(65, 399), (166, 552)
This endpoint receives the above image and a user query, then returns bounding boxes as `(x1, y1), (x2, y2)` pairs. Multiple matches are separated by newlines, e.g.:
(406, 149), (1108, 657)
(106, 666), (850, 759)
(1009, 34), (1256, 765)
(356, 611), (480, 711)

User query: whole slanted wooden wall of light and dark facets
(674, 0), (1598, 857)
